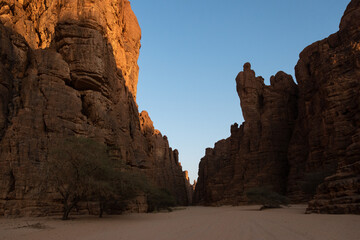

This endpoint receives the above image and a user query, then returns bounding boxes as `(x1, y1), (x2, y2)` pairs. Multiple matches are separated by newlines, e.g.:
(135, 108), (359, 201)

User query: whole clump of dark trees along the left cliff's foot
(42, 137), (179, 220)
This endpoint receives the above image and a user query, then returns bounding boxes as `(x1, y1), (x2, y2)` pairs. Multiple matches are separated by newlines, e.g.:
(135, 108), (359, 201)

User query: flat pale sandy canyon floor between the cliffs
(0, 205), (360, 240)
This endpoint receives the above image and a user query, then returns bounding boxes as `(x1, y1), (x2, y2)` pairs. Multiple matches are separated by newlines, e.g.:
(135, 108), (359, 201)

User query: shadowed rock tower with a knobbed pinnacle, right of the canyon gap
(194, 63), (297, 205)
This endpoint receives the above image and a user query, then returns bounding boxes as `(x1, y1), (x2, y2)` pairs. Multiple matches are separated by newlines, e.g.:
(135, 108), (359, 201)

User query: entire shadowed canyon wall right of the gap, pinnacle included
(194, 1), (360, 213)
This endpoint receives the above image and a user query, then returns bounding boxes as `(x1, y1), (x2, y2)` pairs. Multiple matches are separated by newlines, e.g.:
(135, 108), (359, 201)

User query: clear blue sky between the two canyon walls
(130, 0), (350, 184)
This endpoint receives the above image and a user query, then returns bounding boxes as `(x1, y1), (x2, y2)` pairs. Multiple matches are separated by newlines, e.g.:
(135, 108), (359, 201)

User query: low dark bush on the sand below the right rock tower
(246, 187), (289, 210)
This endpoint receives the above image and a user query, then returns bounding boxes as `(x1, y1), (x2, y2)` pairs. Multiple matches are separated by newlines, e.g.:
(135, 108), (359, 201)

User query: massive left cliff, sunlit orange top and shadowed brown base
(0, 0), (189, 218)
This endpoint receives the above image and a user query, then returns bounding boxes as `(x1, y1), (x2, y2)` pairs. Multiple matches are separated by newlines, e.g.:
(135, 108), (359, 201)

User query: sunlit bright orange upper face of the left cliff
(0, 0), (141, 97)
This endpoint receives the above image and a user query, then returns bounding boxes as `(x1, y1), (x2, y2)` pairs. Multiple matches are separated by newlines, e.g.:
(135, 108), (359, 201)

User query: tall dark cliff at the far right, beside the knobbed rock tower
(288, 1), (360, 200)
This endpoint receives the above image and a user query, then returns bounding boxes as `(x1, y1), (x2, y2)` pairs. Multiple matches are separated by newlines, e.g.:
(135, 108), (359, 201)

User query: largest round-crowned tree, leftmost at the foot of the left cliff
(44, 137), (112, 220)
